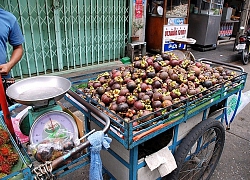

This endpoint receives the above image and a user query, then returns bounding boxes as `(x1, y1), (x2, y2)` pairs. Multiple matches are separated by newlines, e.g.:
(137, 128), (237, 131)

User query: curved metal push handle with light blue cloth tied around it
(52, 90), (110, 169)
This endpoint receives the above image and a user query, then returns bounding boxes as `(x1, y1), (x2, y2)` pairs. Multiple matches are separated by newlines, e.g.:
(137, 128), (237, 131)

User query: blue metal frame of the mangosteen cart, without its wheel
(66, 59), (247, 180)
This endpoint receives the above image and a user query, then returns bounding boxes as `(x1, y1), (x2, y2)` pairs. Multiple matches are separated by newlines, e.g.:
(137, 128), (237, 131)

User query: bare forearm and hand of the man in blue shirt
(0, 44), (23, 75)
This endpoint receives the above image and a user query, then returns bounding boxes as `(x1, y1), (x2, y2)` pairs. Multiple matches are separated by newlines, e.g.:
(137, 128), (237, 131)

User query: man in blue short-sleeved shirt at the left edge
(0, 8), (24, 103)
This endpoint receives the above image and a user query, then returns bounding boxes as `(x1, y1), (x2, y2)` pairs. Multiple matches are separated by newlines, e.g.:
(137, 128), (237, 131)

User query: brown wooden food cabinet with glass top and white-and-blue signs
(146, 0), (190, 53)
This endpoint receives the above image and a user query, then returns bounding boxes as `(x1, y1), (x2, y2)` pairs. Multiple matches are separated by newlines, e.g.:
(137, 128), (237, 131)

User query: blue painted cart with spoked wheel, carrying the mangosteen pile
(66, 59), (247, 180)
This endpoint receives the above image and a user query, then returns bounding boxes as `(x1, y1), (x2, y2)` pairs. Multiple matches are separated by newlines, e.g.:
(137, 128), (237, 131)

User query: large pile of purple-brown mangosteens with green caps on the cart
(79, 52), (236, 125)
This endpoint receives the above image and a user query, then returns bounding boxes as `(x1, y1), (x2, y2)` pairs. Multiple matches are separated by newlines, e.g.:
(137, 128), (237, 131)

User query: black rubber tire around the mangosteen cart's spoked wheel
(163, 118), (225, 180)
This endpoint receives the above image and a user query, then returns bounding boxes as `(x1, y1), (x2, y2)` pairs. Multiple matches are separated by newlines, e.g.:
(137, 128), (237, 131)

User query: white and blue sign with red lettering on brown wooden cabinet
(162, 24), (188, 52)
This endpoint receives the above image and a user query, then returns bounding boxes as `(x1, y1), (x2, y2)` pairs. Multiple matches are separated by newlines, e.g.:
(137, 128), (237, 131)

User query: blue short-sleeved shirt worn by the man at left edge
(0, 8), (24, 77)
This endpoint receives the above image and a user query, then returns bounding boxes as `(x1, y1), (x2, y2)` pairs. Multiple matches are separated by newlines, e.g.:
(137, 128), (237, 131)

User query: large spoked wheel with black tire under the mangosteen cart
(166, 118), (225, 180)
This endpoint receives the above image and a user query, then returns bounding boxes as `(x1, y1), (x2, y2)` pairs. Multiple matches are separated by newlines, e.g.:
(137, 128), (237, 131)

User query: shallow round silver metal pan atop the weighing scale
(6, 76), (71, 106)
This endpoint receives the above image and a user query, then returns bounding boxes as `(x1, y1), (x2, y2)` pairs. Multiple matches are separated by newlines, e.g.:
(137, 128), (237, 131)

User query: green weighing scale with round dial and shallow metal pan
(6, 76), (78, 144)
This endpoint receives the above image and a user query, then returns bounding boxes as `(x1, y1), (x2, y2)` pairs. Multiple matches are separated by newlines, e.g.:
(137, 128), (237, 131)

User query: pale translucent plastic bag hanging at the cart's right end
(226, 91), (250, 122)
